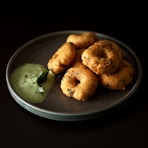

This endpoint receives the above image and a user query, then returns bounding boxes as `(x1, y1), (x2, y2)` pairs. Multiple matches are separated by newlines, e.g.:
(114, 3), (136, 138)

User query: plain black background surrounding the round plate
(0, 4), (148, 148)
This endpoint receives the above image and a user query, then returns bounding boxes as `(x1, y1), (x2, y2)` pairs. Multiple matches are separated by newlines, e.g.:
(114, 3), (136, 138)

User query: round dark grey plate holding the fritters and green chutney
(6, 30), (142, 121)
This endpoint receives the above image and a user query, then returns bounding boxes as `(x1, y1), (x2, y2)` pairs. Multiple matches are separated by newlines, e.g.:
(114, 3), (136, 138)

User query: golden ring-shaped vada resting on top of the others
(81, 41), (120, 75)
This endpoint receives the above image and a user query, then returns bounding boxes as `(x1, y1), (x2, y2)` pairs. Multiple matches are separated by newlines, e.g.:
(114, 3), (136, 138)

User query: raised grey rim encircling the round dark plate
(6, 30), (142, 121)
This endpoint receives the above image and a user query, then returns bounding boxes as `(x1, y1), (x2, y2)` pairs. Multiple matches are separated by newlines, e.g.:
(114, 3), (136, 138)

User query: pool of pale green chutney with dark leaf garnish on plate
(10, 63), (55, 103)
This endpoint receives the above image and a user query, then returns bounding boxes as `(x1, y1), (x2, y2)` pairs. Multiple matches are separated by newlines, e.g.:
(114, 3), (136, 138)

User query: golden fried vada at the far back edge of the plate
(66, 32), (98, 49)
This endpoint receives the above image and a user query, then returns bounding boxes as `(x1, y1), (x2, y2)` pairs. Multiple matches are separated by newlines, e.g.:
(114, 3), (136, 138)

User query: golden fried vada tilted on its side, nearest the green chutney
(47, 42), (76, 74)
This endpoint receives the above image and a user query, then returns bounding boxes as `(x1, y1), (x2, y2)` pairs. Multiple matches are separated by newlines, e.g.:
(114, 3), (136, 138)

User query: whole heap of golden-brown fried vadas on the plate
(47, 32), (134, 101)
